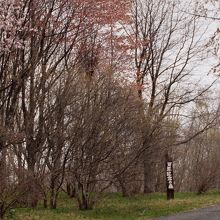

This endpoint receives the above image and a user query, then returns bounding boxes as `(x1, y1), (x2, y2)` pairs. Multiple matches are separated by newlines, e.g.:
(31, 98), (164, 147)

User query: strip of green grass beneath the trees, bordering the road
(6, 191), (220, 220)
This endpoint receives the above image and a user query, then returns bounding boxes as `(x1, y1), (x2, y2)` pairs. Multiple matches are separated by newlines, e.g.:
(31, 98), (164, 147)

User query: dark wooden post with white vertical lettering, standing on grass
(166, 154), (174, 200)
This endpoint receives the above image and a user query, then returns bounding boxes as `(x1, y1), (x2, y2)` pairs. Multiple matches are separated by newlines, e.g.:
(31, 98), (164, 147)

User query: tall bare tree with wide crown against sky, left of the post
(127, 0), (213, 192)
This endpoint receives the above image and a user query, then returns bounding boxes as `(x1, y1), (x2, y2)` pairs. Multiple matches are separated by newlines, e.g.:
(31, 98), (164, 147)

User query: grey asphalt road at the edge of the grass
(154, 205), (220, 220)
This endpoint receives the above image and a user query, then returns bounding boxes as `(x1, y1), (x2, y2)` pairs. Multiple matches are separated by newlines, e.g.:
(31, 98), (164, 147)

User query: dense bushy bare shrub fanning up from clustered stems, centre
(64, 72), (141, 209)
